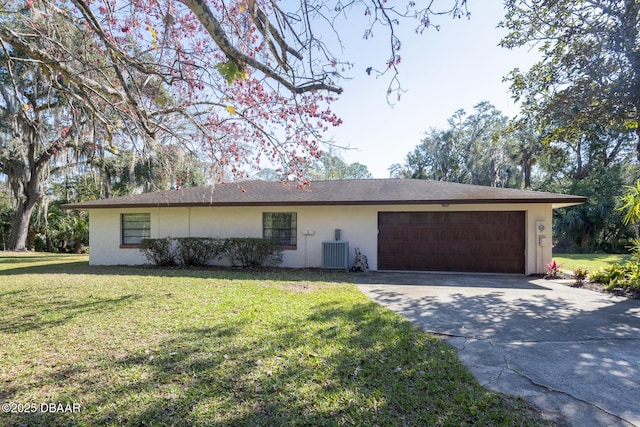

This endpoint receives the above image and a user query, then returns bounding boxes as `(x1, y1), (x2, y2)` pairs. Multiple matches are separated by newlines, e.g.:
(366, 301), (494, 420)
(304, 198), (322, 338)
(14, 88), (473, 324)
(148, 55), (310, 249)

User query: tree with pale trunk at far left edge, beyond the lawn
(0, 44), (81, 250)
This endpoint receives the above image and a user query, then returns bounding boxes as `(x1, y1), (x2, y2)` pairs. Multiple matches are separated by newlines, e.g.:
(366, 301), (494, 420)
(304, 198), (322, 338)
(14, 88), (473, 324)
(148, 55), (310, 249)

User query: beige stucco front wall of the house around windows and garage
(90, 204), (552, 274)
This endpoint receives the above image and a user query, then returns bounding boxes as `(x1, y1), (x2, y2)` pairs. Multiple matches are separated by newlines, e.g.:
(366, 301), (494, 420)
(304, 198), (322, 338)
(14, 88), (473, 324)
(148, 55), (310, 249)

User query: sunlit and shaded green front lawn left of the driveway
(0, 252), (544, 426)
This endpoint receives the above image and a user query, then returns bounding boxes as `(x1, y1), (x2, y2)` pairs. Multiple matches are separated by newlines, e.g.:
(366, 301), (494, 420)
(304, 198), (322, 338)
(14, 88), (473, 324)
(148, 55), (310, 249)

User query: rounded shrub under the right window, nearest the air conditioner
(225, 237), (282, 268)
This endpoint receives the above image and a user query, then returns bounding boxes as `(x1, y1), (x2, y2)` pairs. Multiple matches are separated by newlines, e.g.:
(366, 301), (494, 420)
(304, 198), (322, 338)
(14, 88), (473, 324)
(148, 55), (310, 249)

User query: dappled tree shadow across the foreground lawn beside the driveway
(0, 301), (552, 426)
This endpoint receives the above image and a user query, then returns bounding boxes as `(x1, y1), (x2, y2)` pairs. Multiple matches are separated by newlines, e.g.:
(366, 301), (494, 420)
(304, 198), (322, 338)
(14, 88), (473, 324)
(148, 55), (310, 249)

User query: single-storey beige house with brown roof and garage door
(65, 179), (587, 274)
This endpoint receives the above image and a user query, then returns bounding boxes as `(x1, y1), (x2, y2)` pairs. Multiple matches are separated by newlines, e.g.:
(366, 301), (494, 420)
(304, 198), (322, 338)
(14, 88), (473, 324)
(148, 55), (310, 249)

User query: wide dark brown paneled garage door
(378, 211), (525, 273)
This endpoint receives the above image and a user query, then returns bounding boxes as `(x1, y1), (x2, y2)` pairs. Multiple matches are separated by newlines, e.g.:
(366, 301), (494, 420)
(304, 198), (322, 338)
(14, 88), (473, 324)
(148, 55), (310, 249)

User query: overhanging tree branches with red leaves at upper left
(0, 0), (468, 249)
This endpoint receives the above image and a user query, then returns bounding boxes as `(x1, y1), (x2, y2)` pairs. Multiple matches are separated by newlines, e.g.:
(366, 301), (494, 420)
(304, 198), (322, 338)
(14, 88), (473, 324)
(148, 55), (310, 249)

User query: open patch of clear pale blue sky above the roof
(327, 1), (537, 178)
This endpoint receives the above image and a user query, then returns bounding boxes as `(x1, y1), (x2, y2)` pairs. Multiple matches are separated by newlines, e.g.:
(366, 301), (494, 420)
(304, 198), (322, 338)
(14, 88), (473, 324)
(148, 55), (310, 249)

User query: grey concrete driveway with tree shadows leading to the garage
(356, 273), (640, 427)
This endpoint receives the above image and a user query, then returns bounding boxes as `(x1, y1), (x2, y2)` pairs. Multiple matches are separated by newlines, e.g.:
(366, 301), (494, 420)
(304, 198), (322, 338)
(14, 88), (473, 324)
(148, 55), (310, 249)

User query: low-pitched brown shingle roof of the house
(63, 179), (587, 209)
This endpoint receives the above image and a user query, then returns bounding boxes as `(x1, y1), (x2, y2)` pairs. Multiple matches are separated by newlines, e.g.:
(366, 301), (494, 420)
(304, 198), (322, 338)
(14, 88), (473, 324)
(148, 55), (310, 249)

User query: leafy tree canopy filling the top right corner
(501, 0), (640, 158)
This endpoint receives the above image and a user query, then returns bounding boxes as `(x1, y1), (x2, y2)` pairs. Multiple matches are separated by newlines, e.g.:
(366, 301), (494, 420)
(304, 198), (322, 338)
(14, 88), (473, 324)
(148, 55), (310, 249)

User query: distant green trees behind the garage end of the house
(390, 97), (640, 253)
